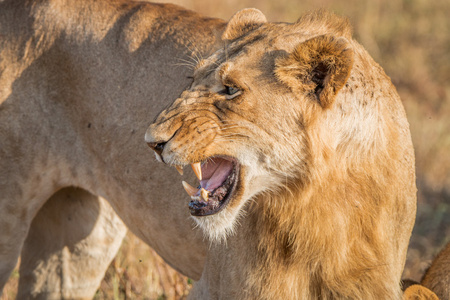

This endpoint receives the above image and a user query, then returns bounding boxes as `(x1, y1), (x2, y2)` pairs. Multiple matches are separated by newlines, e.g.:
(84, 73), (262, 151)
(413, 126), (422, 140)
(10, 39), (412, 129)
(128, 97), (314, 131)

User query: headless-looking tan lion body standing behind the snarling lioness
(0, 0), (225, 299)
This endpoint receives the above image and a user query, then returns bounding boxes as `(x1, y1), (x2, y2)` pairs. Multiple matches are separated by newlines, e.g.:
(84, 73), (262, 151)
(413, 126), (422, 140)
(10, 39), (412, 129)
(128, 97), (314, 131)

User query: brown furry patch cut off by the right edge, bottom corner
(420, 243), (450, 300)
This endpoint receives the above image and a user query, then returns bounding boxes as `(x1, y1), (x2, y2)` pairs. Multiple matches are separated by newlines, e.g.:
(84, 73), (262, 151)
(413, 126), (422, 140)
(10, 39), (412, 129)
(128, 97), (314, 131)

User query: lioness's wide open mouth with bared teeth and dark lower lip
(179, 157), (239, 217)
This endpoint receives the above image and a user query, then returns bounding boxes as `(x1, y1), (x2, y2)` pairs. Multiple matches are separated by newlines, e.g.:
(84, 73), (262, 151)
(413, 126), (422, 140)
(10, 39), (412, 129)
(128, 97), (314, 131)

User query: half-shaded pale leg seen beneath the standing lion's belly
(18, 188), (126, 299)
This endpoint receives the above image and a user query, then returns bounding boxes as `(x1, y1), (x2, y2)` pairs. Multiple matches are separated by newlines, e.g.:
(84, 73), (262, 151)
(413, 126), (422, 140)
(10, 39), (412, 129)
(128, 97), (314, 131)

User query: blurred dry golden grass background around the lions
(1, 0), (450, 300)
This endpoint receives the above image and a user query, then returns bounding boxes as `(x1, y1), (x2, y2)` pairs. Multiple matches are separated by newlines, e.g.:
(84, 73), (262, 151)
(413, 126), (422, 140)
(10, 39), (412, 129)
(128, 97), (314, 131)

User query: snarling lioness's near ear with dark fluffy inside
(275, 35), (353, 108)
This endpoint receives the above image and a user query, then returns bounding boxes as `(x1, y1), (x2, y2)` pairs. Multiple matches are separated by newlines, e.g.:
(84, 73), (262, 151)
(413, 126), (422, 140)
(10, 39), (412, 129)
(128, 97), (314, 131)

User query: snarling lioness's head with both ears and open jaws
(145, 9), (354, 238)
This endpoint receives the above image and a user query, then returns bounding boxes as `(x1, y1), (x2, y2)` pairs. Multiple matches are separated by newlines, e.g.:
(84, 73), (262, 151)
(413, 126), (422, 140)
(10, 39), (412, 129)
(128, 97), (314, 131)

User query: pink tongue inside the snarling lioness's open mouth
(200, 158), (233, 191)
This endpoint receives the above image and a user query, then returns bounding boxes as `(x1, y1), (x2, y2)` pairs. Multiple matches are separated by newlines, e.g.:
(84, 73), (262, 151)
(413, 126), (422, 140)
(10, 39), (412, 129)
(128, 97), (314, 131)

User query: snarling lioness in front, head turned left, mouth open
(145, 9), (416, 299)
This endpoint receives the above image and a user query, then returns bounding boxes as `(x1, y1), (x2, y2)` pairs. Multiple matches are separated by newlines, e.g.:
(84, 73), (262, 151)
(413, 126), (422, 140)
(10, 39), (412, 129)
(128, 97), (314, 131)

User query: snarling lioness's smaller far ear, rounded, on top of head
(222, 8), (267, 40)
